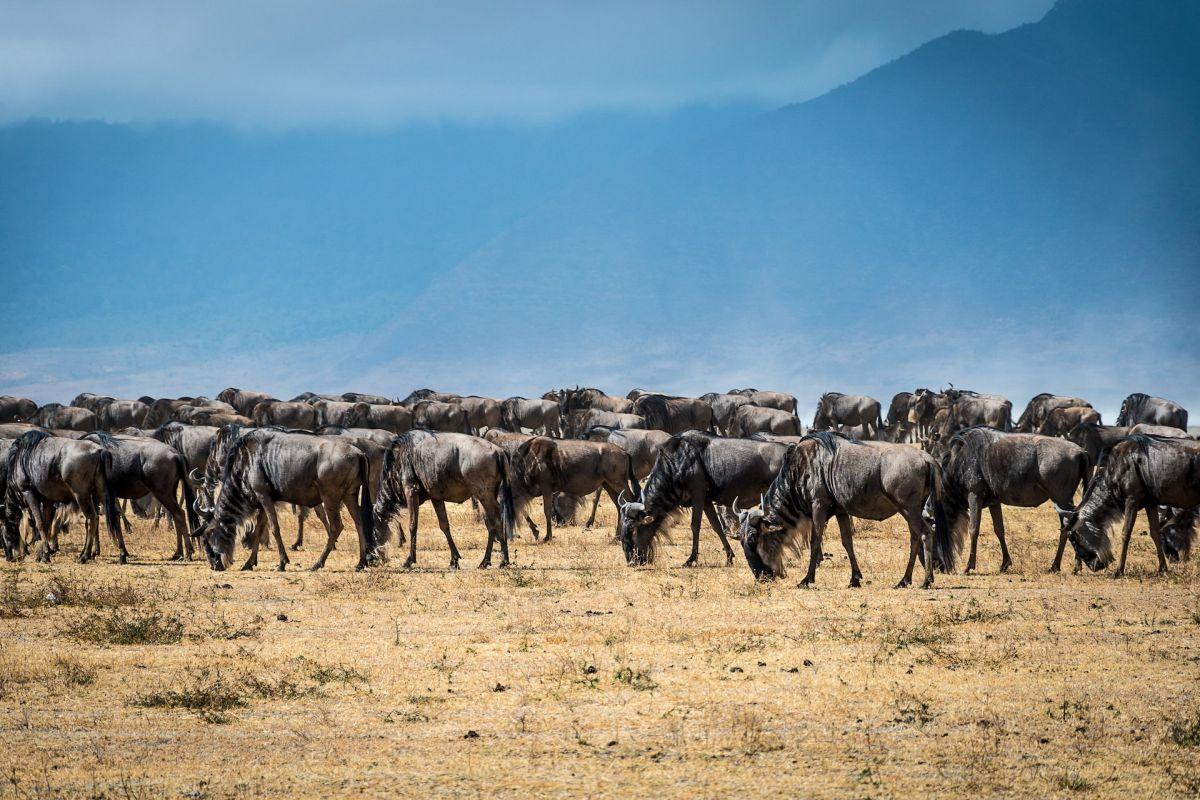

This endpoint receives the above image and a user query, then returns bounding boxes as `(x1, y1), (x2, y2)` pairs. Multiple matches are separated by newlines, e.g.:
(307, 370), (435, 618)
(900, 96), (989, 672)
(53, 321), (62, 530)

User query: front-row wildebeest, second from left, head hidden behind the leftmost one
(84, 431), (199, 561)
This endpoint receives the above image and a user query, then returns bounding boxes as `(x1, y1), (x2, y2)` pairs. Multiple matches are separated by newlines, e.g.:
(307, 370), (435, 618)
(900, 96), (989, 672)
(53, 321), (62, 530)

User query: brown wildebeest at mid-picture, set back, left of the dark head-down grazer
(510, 437), (631, 542)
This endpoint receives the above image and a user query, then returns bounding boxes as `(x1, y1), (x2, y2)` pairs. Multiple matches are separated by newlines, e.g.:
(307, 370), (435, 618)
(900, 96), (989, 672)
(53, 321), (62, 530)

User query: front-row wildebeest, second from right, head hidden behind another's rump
(942, 426), (1092, 572)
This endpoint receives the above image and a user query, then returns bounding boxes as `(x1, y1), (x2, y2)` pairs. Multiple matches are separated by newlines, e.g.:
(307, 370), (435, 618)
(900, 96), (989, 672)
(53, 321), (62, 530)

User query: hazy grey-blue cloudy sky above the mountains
(0, 0), (1052, 127)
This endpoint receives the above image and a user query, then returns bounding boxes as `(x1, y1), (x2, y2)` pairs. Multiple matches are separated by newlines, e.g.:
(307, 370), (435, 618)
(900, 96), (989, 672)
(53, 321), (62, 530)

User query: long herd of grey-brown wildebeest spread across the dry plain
(0, 386), (1200, 587)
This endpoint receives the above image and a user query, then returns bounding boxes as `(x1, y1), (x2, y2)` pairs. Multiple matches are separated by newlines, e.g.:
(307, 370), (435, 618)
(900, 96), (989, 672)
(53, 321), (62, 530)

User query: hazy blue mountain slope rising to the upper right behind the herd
(355, 0), (1200, 409)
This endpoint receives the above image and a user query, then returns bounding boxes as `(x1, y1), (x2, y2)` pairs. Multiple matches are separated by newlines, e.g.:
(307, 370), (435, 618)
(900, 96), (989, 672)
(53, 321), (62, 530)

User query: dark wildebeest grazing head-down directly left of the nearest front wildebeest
(618, 431), (787, 566)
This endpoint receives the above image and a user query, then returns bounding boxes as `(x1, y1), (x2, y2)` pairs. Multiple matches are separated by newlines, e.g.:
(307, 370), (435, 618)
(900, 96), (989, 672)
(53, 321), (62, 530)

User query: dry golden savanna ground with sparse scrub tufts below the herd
(0, 496), (1200, 798)
